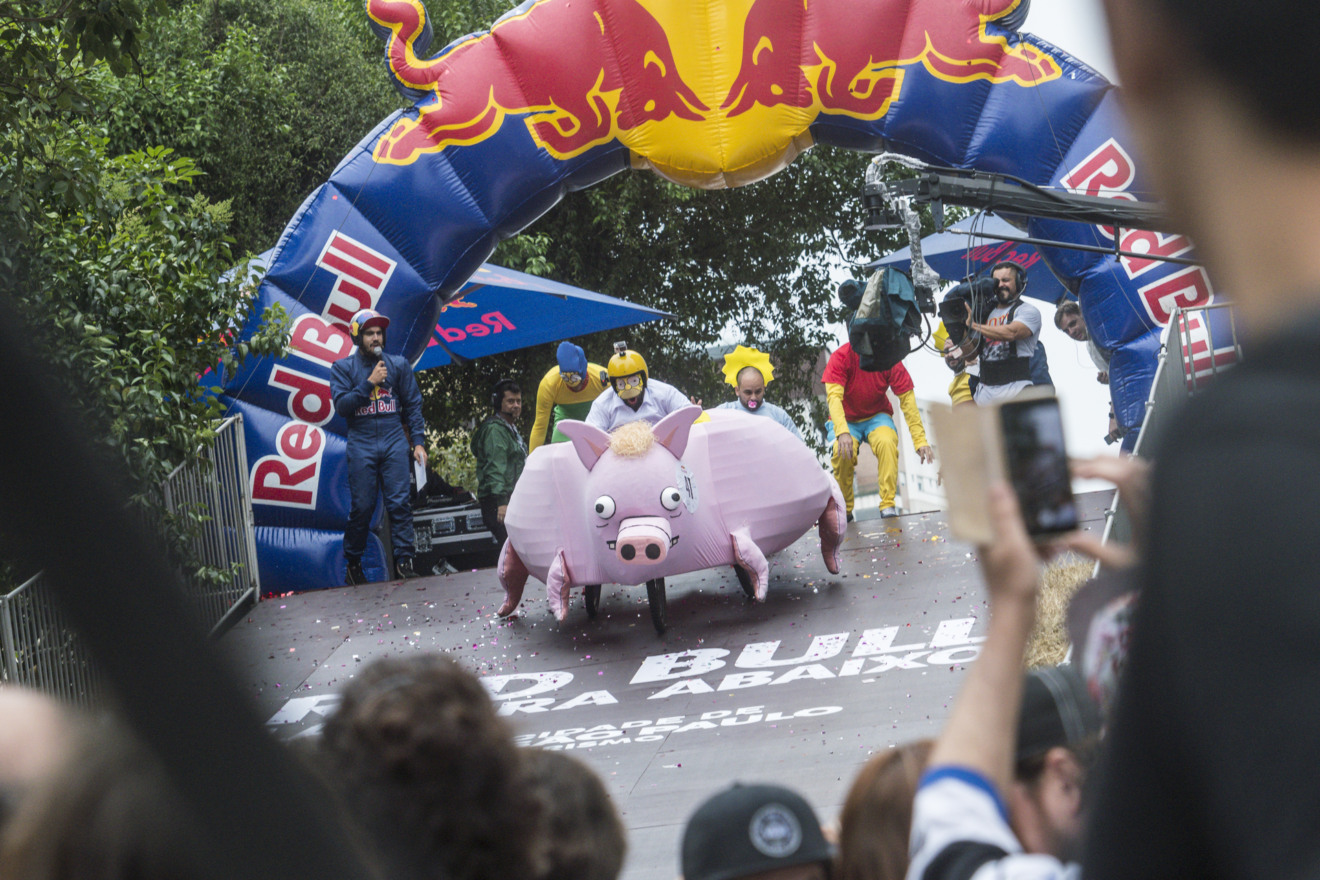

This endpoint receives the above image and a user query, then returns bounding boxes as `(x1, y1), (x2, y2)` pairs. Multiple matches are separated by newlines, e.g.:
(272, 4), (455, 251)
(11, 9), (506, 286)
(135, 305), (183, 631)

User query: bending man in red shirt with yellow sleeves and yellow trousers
(821, 343), (935, 522)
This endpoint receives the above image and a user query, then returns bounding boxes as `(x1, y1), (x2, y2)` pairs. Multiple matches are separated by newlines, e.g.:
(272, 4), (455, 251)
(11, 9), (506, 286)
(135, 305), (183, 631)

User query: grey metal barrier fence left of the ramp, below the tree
(0, 416), (261, 706)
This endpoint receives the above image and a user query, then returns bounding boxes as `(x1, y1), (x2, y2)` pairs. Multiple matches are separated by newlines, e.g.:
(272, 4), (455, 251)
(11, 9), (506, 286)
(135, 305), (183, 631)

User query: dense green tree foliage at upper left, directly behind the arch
(90, 0), (401, 253)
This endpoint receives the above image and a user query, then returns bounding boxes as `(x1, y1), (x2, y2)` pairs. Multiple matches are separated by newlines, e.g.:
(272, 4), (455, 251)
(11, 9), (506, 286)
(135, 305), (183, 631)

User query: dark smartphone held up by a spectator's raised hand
(999, 397), (1077, 536)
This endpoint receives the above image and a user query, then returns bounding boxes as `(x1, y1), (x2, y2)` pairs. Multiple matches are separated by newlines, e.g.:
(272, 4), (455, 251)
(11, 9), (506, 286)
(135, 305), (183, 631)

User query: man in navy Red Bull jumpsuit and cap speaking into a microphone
(330, 309), (426, 584)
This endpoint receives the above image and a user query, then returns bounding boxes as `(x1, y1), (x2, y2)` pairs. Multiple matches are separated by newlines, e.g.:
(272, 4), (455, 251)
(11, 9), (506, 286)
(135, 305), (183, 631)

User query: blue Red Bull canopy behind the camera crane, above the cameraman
(866, 214), (1068, 302)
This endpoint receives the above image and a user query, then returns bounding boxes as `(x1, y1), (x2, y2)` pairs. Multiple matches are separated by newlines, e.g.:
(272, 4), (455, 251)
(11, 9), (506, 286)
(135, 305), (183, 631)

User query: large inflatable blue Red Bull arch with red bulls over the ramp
(223, 0), (1212, 591)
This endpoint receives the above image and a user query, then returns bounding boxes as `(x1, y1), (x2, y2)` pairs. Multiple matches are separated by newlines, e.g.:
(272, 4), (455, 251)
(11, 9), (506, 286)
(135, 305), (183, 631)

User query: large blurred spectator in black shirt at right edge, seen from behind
(1084, 0), (1320, 880)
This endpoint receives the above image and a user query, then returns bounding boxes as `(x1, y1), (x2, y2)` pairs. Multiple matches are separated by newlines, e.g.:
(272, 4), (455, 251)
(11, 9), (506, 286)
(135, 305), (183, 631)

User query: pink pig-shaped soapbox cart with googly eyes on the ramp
(498, 406), (846, 633)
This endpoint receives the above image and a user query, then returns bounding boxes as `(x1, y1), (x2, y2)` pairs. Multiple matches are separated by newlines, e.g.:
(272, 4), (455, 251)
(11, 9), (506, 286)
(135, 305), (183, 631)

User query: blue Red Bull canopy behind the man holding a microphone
(414, 263), (673, 369)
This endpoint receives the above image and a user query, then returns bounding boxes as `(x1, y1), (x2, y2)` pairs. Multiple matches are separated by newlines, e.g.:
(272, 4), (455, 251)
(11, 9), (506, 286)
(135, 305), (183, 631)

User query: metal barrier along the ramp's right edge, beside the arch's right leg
(1096, 302), (1242, 556)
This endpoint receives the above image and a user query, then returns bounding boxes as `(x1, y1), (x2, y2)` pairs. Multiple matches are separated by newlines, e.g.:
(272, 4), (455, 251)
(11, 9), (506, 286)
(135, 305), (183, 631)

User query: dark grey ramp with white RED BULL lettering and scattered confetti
(223, 492), (1110, 880)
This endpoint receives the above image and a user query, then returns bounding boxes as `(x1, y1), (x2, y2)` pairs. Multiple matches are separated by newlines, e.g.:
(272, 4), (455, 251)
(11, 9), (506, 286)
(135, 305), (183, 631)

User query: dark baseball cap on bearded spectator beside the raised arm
(1016, 665), (1102, 761)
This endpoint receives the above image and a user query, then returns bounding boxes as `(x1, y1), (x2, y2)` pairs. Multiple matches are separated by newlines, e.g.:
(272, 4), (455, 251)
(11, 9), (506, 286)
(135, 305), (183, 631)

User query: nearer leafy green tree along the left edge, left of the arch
(0, 12), (286, 585)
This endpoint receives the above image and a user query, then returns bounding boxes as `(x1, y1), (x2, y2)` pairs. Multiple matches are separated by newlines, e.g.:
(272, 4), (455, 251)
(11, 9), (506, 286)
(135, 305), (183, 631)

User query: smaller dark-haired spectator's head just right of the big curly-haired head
(524, 748), (628, 880)
